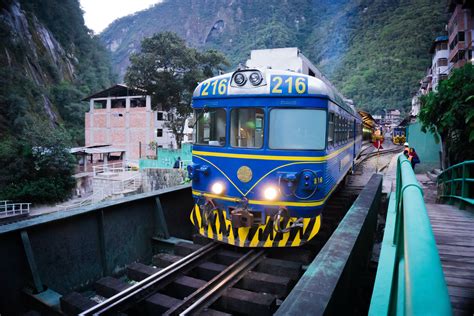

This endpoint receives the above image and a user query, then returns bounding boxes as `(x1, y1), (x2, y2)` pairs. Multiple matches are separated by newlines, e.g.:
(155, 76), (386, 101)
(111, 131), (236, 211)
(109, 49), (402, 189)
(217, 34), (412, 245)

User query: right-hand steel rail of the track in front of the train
(172, 249), (265, 315)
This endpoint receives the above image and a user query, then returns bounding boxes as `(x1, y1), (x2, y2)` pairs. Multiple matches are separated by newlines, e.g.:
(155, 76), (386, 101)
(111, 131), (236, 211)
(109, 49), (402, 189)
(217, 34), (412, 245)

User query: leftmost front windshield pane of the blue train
(194, 109), (226, 146)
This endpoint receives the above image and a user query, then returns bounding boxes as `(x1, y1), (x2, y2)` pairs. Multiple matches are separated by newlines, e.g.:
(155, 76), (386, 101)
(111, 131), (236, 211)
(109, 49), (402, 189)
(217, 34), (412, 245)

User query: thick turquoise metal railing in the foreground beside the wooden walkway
(369, 155), (452, 316)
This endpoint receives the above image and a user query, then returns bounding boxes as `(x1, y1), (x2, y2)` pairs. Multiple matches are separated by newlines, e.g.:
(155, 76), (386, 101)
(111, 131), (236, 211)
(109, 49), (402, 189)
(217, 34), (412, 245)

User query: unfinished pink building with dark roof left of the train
(84, 84), (175, 161)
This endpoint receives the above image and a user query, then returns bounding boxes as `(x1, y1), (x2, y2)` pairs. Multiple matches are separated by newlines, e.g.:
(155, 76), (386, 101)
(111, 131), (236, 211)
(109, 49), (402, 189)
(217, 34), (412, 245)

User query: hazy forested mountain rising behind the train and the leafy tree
(100, 0), (447, 111)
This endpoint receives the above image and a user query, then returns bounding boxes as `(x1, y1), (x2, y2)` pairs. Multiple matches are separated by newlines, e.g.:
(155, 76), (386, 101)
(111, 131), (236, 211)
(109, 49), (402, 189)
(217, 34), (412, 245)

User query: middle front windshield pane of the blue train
(230, 108), (264, 148)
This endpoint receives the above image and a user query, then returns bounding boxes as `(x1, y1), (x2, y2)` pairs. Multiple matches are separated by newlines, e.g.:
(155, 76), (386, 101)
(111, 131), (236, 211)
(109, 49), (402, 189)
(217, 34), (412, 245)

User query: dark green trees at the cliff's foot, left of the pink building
(0, 119), (75, 203)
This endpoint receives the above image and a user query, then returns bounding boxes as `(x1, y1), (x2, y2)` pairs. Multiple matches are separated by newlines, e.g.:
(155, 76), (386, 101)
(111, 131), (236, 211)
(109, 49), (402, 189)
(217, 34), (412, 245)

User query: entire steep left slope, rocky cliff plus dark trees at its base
(0, 0), (113, 202)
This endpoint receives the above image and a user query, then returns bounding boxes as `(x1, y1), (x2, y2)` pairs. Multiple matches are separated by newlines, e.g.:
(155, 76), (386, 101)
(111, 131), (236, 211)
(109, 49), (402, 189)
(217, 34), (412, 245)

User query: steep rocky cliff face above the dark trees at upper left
(0, 0), (112, 141)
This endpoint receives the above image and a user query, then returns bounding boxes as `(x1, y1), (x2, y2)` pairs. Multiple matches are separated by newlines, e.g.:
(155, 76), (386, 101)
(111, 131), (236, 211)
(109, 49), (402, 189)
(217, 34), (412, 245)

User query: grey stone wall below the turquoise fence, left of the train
(140, 169), (187, 192)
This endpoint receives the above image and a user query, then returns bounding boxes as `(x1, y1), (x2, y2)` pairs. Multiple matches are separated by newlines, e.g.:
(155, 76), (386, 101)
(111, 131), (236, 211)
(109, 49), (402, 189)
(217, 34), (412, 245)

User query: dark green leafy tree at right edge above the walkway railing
(419, 64), (474, 166)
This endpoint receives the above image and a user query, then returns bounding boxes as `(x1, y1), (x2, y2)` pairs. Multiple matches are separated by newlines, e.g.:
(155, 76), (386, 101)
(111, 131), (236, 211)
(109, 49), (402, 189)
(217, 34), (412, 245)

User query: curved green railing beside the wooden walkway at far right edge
(437, 160), (474, 208)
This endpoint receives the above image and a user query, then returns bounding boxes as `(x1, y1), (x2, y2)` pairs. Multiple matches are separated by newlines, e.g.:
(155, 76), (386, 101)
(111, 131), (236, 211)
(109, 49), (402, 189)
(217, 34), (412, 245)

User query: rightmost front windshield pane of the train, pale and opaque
(269, 109), (327, 150)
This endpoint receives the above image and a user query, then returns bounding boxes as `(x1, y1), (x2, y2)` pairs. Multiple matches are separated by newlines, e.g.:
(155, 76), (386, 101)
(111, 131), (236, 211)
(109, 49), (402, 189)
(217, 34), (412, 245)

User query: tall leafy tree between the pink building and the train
(125, 32), (228, 148)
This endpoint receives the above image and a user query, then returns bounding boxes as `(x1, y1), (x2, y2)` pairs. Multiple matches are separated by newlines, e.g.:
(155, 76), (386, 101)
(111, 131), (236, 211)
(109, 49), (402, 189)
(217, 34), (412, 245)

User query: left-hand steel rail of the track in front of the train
(79, 243), (220, 316)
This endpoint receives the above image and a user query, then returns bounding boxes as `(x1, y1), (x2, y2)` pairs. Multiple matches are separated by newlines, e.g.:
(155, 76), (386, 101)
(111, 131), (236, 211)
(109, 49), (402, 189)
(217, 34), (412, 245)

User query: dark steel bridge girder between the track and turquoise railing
(275, 174), (382, 316)
